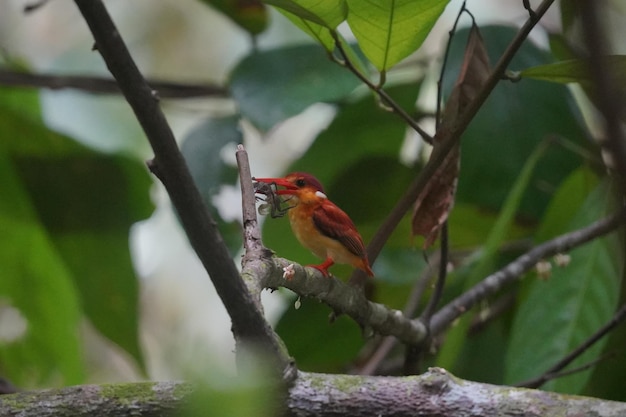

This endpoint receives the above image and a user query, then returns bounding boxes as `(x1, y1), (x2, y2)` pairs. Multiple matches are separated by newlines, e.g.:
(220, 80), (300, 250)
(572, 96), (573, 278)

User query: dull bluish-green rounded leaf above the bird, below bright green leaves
(230, 45), (358, 130)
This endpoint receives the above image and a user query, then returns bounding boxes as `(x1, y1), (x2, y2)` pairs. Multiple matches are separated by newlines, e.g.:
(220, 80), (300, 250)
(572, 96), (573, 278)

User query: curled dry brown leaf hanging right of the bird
(411, 26), (490, 249)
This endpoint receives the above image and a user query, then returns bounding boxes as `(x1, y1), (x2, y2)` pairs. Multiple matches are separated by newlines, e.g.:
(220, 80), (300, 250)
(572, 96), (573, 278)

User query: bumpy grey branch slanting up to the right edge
(430, 208), (626, 335)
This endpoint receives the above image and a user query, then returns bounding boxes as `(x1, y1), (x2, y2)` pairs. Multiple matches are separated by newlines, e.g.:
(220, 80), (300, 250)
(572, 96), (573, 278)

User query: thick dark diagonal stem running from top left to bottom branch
(75, 0), (292, 375)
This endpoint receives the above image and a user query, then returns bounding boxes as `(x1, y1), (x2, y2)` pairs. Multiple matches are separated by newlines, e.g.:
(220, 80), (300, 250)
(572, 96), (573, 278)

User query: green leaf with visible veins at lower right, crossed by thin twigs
(505, 182), (624, 394)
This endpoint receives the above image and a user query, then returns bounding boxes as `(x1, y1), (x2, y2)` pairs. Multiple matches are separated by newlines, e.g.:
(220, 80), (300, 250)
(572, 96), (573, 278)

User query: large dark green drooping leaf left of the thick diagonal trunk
(0, 88), (152, 376)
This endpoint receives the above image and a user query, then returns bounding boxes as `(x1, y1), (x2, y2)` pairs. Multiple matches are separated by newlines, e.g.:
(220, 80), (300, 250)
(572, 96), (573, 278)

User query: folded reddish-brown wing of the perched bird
(313, 200), (366, 258)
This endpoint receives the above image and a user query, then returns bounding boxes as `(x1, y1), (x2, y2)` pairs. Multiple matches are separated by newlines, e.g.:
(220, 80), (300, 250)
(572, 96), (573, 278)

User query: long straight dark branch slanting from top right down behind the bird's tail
(350, 0), (554, 285)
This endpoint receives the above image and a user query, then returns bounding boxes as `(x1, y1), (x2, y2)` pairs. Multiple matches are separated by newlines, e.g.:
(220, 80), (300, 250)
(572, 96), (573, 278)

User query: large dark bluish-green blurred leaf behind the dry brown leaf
(444, 26), (592, 220)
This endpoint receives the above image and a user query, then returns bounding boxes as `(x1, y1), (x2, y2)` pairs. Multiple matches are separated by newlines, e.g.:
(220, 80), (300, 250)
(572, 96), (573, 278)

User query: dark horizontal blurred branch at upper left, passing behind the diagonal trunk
(0, 69), (229, 99)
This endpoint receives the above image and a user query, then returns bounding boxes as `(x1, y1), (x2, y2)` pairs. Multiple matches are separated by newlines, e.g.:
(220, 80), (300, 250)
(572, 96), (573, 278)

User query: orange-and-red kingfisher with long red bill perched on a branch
(254, 172), (374, 276)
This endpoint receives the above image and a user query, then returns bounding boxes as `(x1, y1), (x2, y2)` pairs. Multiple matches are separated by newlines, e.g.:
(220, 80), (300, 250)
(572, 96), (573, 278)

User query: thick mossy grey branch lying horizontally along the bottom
(0, 368), (626, 417)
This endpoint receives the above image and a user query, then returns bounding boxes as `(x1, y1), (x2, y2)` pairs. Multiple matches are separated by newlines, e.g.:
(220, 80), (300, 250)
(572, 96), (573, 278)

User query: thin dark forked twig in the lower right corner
(515, 304), (626, 388)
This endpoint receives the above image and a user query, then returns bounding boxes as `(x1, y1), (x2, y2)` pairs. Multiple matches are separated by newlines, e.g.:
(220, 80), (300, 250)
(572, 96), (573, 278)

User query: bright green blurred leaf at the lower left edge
(0, 150), (85, 387)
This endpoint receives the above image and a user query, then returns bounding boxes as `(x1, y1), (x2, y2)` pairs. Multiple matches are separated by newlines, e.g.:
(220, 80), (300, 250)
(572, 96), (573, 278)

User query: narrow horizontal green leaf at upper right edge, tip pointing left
(520, 55), (626, 87)
